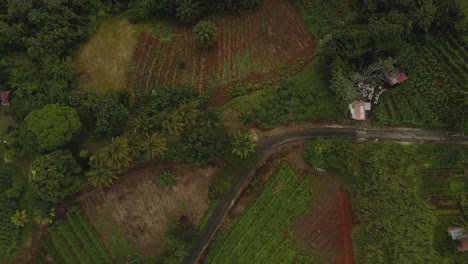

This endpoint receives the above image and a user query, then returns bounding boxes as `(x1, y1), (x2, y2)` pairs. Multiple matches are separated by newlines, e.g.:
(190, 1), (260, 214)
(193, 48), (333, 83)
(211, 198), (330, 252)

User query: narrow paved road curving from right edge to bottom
(183, 125), (468, 264)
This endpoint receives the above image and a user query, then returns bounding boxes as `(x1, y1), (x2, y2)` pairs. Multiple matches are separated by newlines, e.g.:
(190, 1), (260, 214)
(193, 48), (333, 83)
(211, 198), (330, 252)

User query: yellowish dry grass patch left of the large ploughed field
(75, 17), (151, 94)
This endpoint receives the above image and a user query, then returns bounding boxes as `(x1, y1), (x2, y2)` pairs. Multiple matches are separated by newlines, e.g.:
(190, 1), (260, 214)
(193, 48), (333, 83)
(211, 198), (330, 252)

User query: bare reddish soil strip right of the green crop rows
(295, 175), (354, 264)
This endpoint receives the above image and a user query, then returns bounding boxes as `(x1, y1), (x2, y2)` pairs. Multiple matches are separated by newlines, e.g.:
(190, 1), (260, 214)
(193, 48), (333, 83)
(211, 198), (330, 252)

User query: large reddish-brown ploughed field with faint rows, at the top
(129, 0), (314, 97)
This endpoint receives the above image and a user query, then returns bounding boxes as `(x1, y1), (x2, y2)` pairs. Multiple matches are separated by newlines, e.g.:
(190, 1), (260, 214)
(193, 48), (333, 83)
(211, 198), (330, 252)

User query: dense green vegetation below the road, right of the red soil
(303, 139), (468, 263)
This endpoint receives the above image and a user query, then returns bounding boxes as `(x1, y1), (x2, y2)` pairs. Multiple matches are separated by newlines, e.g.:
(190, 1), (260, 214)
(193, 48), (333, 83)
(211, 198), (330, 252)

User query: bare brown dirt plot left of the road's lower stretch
(77, 162), (217, 256)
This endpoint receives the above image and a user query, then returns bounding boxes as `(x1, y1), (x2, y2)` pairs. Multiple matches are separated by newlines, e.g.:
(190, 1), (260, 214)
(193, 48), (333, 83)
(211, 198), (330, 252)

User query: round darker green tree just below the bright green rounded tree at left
(29, 150), (83, 203)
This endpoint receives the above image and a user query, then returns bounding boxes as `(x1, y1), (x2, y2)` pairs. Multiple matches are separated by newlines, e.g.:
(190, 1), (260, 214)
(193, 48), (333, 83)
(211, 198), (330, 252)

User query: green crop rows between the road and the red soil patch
(208, 165), (315, 263)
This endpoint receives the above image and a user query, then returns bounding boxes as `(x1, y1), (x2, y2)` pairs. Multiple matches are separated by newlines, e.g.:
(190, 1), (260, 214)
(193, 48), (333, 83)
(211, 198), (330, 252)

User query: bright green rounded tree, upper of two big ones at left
(25, 104), (81, 150)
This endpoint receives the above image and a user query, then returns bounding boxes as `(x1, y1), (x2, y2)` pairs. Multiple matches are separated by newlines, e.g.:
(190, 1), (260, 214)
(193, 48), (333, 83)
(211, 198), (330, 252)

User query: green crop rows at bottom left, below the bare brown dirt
(42, 208), (112, 264)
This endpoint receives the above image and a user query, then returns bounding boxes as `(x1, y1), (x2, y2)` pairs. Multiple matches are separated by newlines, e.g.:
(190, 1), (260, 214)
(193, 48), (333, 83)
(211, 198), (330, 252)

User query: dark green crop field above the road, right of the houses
(374, 36), (468, 130)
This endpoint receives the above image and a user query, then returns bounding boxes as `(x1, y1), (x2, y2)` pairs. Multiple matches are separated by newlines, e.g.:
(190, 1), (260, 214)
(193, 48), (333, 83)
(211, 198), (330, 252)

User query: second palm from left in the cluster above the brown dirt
(100, 136), (132, 172)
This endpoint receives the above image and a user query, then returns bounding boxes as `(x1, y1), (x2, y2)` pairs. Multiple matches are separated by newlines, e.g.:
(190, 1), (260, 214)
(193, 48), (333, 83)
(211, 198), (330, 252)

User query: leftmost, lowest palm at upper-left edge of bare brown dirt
(85, 155), (117, 188)
